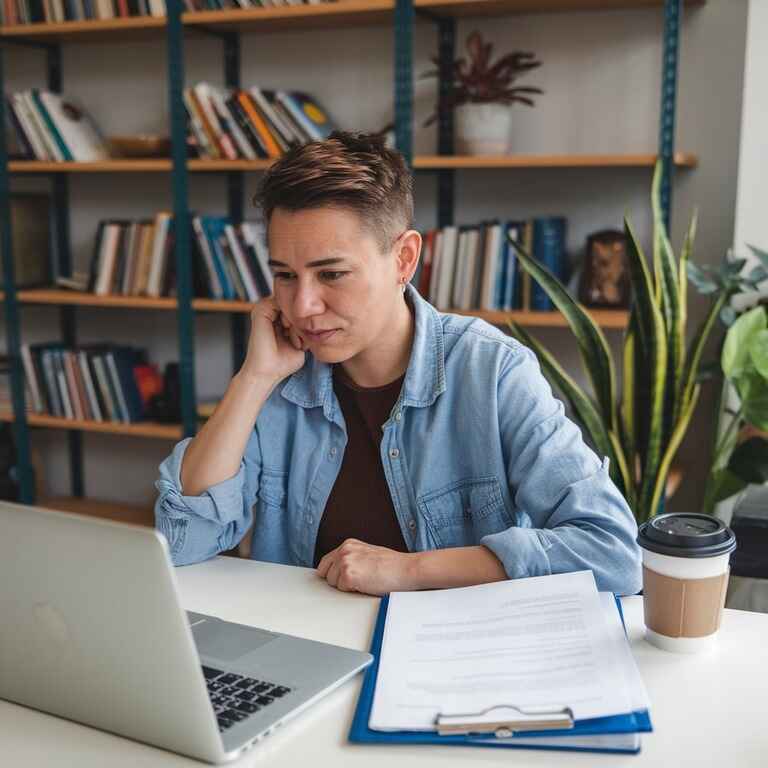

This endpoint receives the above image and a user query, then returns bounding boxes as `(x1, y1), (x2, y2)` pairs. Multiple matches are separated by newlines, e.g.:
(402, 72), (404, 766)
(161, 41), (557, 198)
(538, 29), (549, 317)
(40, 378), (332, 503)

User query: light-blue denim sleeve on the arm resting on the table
(481, 347), (641, 595)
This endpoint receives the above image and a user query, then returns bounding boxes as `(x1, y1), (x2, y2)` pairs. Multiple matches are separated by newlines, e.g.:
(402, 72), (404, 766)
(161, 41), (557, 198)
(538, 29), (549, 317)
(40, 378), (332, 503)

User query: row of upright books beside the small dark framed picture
(415, 216), (567, 311)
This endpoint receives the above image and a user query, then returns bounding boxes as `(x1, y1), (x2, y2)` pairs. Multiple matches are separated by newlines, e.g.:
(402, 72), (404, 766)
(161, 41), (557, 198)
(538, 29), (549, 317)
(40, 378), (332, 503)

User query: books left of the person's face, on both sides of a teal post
(80, 211), (272, 301)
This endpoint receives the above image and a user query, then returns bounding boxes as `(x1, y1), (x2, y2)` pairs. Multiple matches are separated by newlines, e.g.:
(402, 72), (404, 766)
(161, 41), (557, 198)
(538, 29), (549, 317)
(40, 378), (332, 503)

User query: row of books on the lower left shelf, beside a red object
(21, 343), (162, 424)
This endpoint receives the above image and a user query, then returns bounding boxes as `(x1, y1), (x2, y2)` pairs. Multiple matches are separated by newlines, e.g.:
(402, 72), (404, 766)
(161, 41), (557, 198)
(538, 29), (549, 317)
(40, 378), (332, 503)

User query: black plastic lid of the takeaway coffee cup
(637, 512), (736, 557)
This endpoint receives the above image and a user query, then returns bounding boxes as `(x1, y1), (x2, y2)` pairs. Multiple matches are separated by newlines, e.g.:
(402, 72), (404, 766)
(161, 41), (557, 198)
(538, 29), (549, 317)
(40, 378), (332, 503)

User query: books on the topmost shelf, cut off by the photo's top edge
(0, 0), (336, 25)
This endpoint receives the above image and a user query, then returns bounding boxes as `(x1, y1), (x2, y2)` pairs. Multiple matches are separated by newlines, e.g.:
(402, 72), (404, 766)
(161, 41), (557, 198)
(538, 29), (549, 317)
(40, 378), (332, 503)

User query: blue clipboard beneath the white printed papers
(349, 596), (653, 754)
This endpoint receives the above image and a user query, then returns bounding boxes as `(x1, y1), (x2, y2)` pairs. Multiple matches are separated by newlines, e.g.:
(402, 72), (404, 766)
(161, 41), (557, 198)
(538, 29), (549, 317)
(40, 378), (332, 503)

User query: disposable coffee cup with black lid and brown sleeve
(637, 513), (736, 653)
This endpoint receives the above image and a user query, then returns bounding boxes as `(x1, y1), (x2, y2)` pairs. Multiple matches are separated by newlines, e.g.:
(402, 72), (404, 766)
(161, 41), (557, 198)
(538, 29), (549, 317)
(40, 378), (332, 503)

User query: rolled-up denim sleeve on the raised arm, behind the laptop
(155, 438), (253, 565)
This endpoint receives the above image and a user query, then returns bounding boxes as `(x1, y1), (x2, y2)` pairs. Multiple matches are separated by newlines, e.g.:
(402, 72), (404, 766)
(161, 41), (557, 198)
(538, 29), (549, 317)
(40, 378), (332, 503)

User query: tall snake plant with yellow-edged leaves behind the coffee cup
(509, 162), (754, 522)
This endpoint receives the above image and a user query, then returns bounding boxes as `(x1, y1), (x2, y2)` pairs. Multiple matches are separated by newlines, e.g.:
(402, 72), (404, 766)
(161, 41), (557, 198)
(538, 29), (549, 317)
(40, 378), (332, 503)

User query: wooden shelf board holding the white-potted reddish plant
(413, 152), (698, 170)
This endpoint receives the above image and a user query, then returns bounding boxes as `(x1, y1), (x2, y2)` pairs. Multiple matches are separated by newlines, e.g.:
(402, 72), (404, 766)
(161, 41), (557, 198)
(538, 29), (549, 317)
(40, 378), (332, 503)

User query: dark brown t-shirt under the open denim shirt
(315, 365), (408, 566)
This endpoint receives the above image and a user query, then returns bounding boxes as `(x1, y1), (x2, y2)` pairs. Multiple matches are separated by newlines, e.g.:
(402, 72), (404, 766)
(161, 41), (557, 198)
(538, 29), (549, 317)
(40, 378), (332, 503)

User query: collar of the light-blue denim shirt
(280, 284), (445, 420)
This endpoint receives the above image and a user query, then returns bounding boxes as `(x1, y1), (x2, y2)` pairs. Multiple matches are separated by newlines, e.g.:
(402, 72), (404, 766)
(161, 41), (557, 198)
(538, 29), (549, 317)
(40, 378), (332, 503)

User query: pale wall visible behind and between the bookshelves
(5, 0), (746, 510)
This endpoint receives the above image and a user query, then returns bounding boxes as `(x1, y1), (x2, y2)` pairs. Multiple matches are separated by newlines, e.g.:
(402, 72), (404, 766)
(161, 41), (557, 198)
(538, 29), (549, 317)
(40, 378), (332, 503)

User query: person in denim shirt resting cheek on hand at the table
(156, 132), (641, 594)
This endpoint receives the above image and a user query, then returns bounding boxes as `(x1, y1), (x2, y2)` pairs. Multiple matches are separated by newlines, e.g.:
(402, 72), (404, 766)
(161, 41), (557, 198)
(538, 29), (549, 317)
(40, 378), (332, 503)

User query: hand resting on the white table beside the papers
(317, 539), (414, 595)
